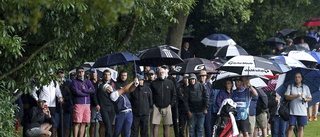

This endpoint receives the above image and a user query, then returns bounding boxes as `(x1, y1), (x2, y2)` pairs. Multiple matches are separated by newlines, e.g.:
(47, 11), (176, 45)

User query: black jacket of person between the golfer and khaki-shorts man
(130, 86), (153, 116)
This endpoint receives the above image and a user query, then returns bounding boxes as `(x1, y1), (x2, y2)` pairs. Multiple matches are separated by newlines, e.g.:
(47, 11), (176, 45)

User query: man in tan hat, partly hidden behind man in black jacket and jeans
(199, 70), (214, 137)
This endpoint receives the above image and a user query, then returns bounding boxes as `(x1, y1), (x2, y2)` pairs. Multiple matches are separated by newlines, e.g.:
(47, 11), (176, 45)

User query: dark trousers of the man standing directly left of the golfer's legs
(100, 107), (116, 137)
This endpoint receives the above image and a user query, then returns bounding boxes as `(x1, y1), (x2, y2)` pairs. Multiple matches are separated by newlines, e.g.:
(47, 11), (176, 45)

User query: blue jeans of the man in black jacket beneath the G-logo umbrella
(189, 112), (204, 137)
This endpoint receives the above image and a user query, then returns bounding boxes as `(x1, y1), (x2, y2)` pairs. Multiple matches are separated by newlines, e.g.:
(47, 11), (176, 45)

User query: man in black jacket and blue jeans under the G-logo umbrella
(185, 74), (209, 137)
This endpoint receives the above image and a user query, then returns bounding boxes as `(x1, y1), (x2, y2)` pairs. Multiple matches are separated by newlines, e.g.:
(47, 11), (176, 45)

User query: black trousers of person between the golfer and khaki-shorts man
(131, 115), (149, 137)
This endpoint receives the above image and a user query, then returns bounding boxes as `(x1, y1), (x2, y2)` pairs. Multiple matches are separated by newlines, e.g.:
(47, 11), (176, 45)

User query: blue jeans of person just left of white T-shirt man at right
(271, 115), (288, 137)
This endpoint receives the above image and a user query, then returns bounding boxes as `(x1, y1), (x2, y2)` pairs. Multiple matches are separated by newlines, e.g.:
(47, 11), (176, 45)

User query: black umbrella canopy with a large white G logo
(173, 58), (222, 74)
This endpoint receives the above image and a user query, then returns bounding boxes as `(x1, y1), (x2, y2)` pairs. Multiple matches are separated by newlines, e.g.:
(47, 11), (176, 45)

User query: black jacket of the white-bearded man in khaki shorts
(150, 78), (176, 108)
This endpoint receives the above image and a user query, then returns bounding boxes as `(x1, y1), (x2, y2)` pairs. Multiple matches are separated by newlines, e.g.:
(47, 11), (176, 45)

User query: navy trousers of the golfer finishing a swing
(113, 111), (133, 137)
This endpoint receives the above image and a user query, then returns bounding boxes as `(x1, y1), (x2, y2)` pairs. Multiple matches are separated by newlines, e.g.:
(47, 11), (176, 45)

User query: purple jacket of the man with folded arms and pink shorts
(71, 78), (95, 104)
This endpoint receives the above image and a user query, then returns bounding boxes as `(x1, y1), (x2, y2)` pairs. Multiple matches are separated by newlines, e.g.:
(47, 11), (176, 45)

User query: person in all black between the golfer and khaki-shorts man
(130, 75), (153, 137)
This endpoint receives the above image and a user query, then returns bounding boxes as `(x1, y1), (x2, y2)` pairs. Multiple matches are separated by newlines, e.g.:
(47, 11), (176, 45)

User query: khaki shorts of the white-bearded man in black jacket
(152, 105), (172, 125)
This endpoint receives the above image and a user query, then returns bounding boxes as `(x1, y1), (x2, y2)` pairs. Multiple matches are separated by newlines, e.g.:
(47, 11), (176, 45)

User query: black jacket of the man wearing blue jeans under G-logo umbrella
(184, 82), (209, 112)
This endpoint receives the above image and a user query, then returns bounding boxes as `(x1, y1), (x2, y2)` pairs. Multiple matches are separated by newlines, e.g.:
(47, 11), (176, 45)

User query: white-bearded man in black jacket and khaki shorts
(151, 68), (176, 137)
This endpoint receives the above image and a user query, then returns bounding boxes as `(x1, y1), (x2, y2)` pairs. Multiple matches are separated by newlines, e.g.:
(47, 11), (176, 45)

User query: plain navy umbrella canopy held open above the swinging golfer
(93, 52), (139, 68)
